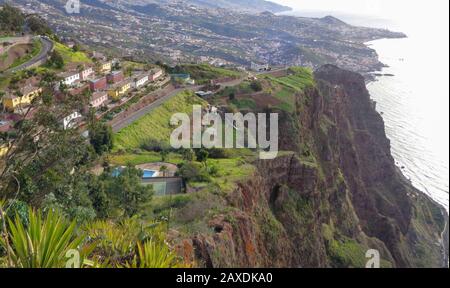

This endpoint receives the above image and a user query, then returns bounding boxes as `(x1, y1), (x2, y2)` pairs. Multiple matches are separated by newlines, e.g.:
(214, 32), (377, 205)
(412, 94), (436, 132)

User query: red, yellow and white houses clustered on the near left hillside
(0, 40), (170, 156)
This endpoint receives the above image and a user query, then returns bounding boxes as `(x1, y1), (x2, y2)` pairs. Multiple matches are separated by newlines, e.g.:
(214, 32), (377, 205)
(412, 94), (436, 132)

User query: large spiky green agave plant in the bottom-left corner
(0, 209), (91, 268)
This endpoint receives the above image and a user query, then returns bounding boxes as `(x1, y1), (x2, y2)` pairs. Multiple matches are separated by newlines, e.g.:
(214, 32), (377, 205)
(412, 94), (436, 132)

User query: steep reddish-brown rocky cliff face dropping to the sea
(178, 65), (448, 267)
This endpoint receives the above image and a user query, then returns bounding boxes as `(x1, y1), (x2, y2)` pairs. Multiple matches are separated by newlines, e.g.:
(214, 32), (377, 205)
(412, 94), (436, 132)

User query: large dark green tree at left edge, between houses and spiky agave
(0, 77), (95, 217)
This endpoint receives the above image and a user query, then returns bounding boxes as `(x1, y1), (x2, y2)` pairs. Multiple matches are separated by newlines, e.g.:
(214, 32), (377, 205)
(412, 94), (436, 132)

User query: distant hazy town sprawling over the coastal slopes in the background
(8, 0), (404, 73)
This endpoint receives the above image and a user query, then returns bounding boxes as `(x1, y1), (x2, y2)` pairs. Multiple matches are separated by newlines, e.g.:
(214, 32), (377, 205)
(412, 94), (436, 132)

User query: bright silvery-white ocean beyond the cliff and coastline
(285, 11), (449, 211)
